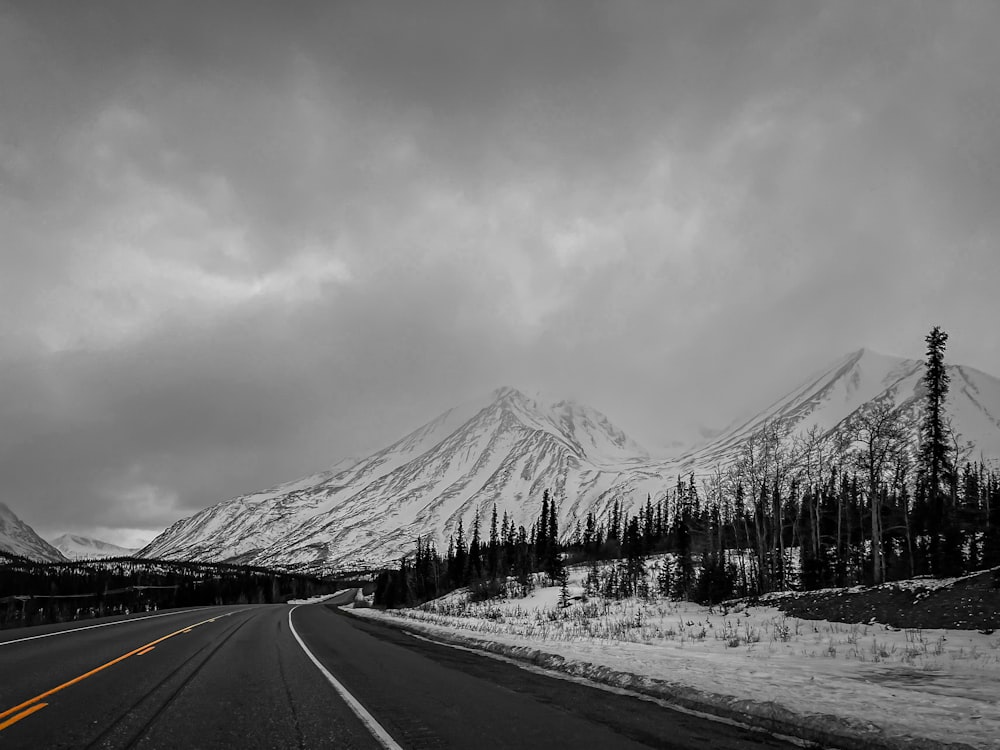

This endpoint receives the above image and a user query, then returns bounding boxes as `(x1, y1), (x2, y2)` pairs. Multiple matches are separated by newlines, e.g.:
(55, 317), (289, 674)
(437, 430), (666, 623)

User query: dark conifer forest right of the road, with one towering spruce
(376, 327), (1000, 606)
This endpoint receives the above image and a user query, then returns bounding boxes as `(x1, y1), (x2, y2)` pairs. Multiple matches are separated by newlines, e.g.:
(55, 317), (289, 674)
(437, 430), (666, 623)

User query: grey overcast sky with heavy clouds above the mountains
(0, 0), (1000, 543)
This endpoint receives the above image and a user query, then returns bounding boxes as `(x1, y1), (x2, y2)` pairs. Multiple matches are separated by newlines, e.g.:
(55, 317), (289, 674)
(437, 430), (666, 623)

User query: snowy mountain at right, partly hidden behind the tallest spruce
(679, 349), (1000, 469)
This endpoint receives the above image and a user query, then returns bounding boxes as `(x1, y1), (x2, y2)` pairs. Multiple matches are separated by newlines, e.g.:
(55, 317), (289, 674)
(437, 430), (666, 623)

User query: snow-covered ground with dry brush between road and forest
(356, 569), (1000, 748)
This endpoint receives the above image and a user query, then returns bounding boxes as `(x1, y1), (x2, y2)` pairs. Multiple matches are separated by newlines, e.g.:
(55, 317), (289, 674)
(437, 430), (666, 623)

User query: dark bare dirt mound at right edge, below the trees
(768, 568), (1000, 631)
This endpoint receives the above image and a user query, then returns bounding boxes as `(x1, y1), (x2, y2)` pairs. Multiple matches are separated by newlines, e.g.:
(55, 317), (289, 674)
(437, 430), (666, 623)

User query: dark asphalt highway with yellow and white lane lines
(0, 595), (793, 750)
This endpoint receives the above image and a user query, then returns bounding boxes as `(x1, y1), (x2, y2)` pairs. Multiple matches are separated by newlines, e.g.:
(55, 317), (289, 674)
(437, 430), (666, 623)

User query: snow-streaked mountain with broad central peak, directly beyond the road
(140, 388), (662, 566)
